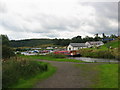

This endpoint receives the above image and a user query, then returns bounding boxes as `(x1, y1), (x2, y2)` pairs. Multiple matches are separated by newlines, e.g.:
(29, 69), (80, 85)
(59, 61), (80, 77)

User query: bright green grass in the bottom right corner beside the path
(93, 64), (118, 88)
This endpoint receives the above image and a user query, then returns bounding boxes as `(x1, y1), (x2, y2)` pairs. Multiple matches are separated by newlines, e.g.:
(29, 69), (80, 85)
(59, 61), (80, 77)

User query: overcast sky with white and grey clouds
(0, 0), (118, 40)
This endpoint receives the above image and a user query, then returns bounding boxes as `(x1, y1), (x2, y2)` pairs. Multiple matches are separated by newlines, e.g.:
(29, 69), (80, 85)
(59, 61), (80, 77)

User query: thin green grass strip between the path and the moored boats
(21, 55), (84, 63)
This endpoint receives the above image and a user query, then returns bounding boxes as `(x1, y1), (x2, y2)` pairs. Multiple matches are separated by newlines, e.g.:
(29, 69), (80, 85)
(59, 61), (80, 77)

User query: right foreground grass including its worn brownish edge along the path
(75, 64), (118, 88)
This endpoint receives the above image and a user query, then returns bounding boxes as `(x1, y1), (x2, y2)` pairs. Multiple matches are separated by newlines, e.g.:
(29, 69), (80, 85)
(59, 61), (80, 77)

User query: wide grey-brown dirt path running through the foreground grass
(35, 61), (98, 88)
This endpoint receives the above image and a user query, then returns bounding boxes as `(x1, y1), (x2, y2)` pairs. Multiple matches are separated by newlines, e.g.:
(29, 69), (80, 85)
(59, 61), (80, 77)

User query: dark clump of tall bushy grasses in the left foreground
(2, 59), (48, 88)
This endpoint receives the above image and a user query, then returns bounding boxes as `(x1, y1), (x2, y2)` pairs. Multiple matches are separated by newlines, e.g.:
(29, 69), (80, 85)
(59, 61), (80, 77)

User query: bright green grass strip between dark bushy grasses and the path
(11, 64), (56, 88)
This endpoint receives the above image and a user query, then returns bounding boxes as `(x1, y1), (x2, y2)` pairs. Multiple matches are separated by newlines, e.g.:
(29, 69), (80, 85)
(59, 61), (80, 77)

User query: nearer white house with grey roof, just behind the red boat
(67, 43), (87, 51)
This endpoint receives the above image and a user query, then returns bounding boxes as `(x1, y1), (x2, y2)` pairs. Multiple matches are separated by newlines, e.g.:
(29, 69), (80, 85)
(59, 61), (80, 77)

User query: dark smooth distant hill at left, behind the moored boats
(10, 39), (53, 47)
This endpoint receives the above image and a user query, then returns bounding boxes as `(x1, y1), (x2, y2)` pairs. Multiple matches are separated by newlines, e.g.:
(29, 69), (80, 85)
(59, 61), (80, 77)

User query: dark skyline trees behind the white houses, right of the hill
(53, 33), (118, 46)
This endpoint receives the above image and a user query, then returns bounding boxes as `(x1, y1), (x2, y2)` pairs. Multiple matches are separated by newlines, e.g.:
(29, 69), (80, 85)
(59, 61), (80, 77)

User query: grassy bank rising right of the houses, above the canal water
(79, 39), (120, 59)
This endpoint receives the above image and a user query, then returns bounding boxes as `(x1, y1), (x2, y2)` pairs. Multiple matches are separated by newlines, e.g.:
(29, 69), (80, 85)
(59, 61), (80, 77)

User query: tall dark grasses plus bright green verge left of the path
(2, 57), (56, 89)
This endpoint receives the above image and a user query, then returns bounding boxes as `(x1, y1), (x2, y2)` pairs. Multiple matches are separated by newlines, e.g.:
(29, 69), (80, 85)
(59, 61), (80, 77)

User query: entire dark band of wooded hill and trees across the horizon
(2, 33), (117, 47)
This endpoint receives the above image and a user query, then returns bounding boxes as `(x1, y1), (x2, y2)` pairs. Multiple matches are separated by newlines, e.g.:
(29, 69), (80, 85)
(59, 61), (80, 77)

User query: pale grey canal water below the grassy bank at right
(69, 57), (118, 62)
